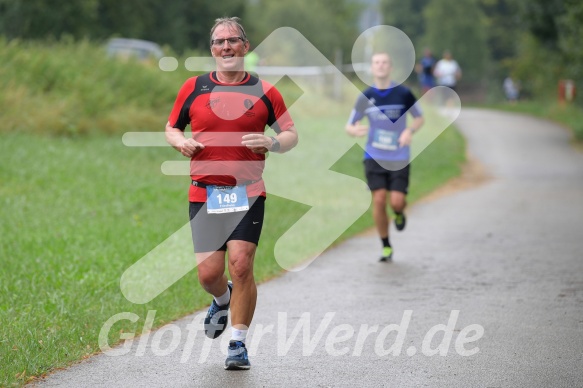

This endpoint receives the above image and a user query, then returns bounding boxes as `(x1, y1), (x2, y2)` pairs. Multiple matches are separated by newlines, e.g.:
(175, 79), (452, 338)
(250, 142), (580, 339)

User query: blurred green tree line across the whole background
(0, 0), (583, 100)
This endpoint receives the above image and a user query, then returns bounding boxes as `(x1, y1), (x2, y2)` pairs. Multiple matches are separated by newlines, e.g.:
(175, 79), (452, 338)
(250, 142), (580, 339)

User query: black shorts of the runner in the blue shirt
(364, 159), (410, 194)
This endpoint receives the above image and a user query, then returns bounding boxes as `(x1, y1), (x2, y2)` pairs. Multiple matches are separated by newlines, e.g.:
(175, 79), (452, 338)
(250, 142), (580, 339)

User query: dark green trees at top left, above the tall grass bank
(0, 0), (246, 51)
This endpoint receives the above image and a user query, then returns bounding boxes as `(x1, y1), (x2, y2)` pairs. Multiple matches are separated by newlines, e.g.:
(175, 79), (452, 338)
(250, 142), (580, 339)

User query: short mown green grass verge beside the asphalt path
(0, 116), (463, 385)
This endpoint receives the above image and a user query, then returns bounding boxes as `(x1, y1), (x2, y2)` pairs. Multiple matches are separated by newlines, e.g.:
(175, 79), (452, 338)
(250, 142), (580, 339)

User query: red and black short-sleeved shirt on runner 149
(168, 72), (294, 202)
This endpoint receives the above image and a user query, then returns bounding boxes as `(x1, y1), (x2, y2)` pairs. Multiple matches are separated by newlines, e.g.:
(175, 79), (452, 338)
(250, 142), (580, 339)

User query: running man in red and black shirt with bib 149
(166, 17), (298, 369)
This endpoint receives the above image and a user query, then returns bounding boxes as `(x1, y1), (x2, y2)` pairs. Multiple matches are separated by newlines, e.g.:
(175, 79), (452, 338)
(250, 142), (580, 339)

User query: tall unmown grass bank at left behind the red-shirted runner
(0, 37), (192, 136)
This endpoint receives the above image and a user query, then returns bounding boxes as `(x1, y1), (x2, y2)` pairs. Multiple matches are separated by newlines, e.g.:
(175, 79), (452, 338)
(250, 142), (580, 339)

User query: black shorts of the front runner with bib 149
(189, 196), (265, 252)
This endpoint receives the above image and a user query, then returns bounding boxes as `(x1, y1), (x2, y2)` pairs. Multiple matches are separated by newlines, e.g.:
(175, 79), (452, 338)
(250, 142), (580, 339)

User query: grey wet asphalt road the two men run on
(34, 109), (583, 387)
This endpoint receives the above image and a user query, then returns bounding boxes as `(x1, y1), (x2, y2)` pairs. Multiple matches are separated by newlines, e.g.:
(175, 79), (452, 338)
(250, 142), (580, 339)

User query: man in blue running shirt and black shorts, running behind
(346, 52), (424, 261)
